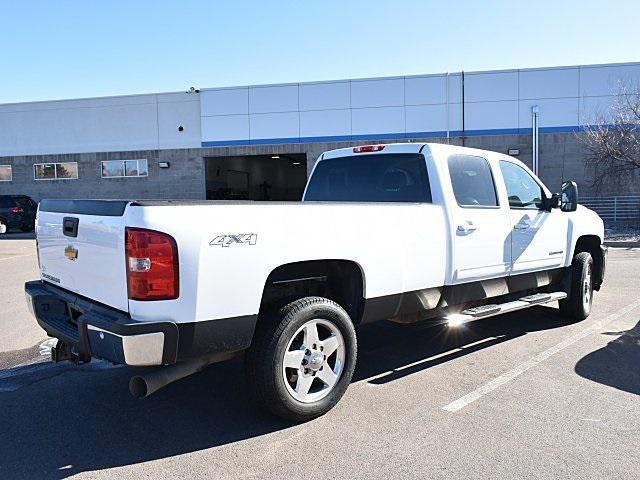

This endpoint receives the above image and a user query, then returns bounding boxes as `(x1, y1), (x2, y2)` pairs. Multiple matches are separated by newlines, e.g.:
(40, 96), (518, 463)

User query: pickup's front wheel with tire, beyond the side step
(559, 252), (593, 320)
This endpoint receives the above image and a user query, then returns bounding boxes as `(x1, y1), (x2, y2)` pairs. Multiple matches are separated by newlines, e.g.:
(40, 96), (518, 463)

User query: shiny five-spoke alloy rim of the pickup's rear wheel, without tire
(282, 319), (345, 403)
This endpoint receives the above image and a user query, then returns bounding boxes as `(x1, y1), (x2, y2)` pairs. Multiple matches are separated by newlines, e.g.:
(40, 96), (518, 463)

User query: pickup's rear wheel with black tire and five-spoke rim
(245, 297), (357, 422)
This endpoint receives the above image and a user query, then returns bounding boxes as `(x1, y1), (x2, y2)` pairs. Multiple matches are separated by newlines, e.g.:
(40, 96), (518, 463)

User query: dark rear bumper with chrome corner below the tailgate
(25, 281), (178, 366)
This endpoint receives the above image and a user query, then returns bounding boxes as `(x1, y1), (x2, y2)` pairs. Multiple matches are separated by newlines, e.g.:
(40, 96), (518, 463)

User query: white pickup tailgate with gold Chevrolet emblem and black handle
(37, 200), (129, 311)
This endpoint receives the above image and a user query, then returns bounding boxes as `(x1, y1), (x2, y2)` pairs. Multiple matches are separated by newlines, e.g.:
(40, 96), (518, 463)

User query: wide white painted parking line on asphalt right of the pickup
(442, 300), (640, 412)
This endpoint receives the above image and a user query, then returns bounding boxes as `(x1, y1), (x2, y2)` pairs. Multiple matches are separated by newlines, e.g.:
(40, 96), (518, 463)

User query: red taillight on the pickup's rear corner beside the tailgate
(126, 228), (180, 300)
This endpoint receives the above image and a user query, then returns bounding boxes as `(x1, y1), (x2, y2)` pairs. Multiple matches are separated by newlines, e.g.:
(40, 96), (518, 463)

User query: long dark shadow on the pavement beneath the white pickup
(0, 307), (580, 479)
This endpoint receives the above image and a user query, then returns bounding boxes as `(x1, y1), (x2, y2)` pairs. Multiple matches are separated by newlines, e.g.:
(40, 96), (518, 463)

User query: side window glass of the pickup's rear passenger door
(448, 155), (498, 207)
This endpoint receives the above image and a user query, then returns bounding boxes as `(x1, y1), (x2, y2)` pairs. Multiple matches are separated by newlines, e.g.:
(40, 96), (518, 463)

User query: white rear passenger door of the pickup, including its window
(447, 154), (511, 283)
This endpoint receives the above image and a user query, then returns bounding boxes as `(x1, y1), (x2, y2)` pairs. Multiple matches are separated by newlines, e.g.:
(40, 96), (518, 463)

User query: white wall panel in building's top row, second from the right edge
(520, 68), (580, 100)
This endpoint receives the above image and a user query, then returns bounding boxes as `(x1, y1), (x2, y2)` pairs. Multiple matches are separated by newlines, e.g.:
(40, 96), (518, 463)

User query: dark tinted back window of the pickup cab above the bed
(304, 153), (431, 203)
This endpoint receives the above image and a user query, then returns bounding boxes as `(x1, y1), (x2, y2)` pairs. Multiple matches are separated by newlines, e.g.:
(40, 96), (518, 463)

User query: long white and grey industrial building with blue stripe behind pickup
(0, 63), (640, 200)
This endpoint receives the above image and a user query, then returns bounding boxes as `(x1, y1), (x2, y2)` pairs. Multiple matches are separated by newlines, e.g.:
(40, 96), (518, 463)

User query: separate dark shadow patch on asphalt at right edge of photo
(575, 322), (640, 395)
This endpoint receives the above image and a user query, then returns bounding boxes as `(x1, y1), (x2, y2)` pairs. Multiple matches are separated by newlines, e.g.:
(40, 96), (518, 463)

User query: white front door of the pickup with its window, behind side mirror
(500, 160), (567, 274)
